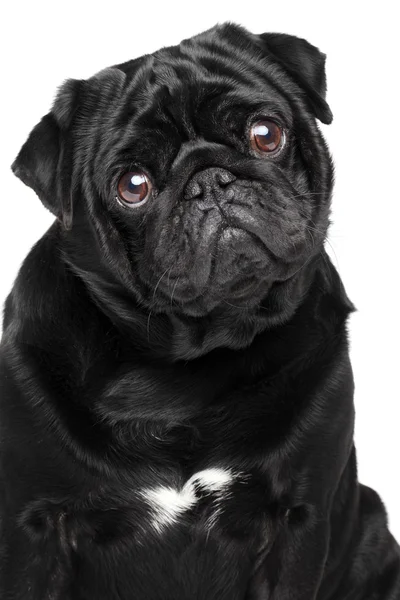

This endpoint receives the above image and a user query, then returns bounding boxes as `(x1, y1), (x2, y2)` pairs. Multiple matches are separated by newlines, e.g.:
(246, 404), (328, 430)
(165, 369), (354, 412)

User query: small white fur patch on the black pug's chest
(141, 467), (237, 533)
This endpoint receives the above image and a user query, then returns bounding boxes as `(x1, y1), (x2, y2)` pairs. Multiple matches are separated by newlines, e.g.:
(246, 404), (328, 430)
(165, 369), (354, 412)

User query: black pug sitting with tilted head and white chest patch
(0, 24), (400, 600)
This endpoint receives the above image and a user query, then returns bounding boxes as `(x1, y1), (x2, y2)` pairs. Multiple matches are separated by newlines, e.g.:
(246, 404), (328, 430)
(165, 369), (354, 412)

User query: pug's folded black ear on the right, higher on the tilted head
(259, 33), (333, 124)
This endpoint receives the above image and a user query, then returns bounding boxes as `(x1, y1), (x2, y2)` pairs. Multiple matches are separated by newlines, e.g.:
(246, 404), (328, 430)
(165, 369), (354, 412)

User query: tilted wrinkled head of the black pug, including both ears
(14, 25), (332, 338)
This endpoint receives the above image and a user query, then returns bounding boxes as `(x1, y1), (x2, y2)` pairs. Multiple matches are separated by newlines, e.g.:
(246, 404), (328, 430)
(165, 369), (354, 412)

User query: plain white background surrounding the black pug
(0, 0), (400, 540)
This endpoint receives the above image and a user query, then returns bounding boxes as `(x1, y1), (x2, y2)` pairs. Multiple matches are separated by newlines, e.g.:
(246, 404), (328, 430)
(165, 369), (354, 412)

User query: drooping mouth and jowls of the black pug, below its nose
(138, 223), (304, 317)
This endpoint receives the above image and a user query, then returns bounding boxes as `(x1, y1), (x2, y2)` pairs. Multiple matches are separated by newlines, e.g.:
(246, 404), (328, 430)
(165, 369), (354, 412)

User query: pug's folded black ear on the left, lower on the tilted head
(11, 79), (82, 229)
